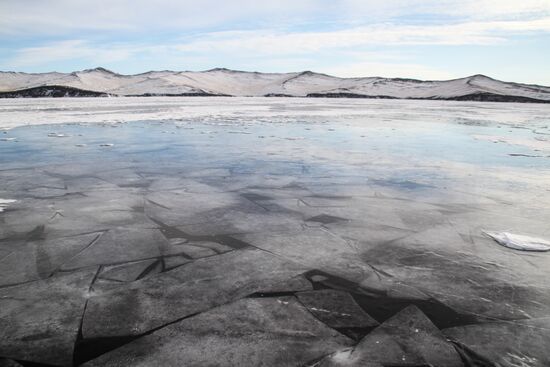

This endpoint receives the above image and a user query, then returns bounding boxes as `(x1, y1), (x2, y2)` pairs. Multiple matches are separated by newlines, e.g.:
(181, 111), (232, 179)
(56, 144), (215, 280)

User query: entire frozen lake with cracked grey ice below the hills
(0, 97), (550, 366)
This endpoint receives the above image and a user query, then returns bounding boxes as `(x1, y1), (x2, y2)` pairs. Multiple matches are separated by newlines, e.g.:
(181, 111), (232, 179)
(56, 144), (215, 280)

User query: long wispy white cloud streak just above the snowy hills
(8, 17), (550, 66)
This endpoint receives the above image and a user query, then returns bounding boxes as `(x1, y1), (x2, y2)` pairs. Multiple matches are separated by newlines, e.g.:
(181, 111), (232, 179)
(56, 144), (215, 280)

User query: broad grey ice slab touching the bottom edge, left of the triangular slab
(85, 297), (352, 366)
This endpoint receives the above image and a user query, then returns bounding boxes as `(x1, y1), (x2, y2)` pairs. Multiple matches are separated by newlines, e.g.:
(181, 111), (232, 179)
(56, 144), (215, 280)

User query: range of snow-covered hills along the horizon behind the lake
(0, 68), (550, 103)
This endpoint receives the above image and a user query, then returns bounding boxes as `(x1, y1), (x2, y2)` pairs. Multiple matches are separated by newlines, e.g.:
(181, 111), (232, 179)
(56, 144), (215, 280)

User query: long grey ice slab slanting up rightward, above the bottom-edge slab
(82, 250), (304, 338)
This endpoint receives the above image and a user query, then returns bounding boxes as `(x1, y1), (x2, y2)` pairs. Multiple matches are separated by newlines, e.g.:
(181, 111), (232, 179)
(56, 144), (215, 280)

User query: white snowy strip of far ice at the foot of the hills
(0, 97), (550, 133)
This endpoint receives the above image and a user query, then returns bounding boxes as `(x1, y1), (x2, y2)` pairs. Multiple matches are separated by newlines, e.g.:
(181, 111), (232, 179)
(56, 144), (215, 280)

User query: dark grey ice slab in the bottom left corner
(0, 269), (96, 366)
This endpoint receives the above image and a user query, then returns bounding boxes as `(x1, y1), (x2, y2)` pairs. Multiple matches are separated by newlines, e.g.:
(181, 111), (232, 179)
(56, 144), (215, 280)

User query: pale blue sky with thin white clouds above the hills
(0, 0), (550, 85)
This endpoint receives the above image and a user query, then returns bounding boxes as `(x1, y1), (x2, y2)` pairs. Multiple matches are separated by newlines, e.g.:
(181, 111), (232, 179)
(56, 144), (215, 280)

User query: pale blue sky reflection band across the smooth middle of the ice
(0, 103), (550, 201)
